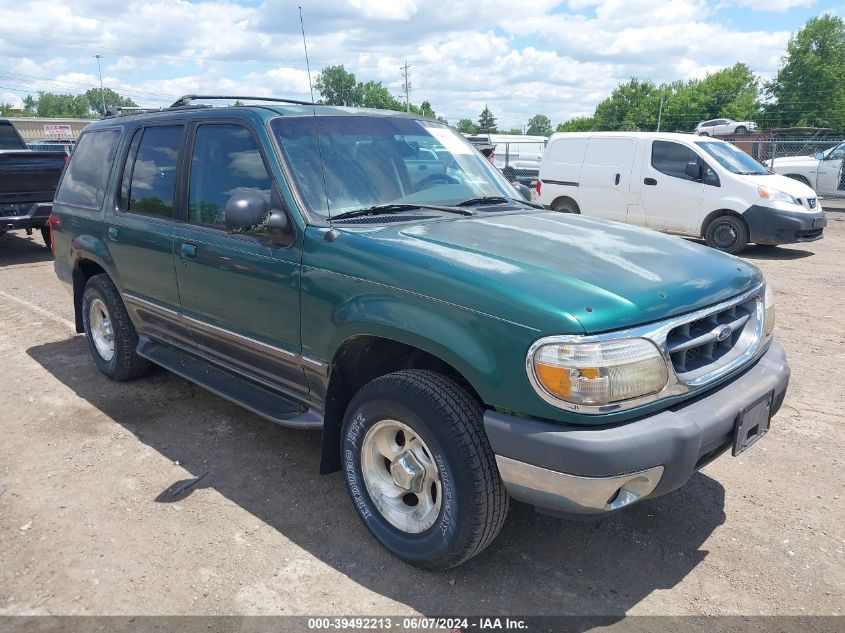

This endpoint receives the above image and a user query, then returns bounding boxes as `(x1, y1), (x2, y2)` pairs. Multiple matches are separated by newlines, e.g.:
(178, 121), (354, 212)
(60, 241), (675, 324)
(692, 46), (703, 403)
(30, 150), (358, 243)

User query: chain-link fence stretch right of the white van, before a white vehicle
(725, 136), (845, 211)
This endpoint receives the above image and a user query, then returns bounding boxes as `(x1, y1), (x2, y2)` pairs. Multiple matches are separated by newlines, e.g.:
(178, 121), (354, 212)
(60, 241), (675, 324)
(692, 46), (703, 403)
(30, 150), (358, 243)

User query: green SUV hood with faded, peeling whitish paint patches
(326, 212), (762, 334)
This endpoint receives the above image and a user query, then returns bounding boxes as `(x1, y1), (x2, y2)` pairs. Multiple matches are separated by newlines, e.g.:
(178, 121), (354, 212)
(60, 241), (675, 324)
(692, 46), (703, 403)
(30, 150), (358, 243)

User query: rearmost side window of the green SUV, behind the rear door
(56, 130), (120, 209)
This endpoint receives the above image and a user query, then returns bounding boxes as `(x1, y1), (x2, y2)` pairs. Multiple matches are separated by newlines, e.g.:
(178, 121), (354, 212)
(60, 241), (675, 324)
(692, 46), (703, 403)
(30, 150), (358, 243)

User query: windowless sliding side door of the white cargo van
(578, 136), (636, 222)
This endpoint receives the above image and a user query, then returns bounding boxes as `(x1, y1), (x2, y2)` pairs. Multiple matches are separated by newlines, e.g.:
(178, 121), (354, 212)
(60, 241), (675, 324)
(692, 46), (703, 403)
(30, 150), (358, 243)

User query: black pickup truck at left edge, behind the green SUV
(0, 119), (66, 248)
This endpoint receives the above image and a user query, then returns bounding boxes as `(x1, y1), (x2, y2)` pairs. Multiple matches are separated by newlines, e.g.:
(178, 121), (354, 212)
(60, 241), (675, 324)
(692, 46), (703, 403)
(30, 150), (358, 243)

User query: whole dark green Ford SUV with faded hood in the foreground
(50, 98), (789, 568)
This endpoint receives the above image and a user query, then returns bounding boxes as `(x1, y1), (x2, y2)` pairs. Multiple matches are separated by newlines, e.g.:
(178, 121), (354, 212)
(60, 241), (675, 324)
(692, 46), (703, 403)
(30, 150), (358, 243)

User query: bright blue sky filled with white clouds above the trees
(0, 0), (845, 127)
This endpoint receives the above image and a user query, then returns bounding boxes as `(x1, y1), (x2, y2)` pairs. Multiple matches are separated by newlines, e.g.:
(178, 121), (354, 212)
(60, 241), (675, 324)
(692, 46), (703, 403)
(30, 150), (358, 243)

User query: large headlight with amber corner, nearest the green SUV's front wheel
(528, 338), (668, 406)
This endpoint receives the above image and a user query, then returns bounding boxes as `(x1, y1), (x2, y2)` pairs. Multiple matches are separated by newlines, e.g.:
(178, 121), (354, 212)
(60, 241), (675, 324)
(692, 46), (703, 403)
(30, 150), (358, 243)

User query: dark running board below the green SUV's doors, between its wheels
(138, 338), (323, 429)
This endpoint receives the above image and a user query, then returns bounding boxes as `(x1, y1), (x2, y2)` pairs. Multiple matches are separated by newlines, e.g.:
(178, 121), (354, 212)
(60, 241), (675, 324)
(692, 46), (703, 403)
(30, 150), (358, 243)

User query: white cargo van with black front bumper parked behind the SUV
(536, 132), (826, 254)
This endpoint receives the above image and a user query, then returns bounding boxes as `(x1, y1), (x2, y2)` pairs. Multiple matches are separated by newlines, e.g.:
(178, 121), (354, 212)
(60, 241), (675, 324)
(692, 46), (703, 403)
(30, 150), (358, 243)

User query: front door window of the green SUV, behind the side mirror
(188, 123), (273, 228)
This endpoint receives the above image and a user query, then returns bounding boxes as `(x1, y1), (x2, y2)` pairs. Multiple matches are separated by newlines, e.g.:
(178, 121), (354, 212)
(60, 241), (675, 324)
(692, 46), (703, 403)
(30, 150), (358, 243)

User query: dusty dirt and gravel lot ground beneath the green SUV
(0, 213), (845, 615)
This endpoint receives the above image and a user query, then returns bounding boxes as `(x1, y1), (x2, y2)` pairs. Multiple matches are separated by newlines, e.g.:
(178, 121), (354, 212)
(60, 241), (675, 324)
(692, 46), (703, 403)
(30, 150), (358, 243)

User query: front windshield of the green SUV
(272, 116), (517, 216)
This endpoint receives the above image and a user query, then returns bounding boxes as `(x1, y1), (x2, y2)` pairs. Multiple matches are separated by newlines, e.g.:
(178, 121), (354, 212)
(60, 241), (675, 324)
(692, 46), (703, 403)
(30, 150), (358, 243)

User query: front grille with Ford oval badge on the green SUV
(666, 297), (762, 382)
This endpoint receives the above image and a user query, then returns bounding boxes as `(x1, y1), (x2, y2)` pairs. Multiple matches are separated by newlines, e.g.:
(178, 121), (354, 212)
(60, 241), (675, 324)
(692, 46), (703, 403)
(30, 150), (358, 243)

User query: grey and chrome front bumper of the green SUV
(484, 342), (790, 514)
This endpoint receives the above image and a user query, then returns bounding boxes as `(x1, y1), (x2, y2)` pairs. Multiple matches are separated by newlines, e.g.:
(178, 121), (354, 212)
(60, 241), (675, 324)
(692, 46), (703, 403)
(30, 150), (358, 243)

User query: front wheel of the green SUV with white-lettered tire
(341, 370), (508, 569)
